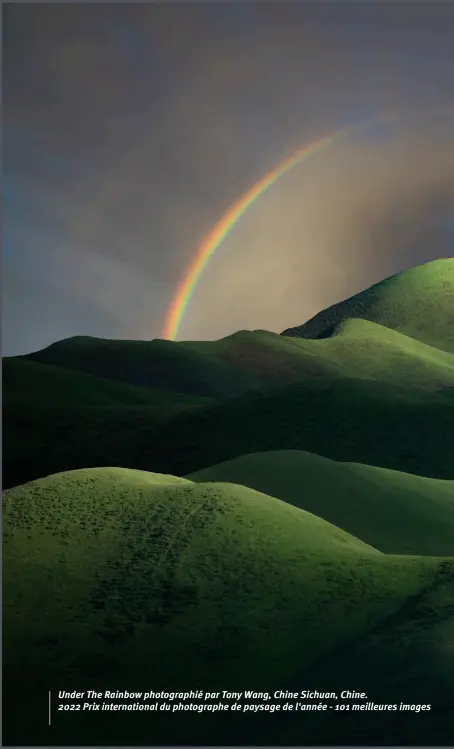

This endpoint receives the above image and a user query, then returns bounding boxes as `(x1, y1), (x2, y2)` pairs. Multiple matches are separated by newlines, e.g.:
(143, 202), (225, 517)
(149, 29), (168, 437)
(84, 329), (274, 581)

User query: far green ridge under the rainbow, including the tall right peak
(12, 258), (454, 406)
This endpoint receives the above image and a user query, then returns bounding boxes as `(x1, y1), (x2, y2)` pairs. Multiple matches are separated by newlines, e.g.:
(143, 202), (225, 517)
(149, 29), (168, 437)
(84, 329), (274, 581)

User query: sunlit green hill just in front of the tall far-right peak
(183, 318), (454, 389)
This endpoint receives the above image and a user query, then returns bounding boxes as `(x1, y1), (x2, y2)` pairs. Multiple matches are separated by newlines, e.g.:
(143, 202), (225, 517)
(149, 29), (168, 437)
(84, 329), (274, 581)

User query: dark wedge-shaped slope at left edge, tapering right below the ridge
(2, 357), (208, 407)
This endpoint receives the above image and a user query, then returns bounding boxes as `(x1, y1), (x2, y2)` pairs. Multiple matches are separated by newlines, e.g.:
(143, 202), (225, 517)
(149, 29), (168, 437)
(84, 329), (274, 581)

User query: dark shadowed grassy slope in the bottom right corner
(248, 568), (454, 746)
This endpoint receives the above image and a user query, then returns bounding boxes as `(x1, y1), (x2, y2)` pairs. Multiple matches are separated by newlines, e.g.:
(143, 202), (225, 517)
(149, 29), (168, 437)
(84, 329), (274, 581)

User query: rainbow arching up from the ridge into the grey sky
(162, 116), (392, 341)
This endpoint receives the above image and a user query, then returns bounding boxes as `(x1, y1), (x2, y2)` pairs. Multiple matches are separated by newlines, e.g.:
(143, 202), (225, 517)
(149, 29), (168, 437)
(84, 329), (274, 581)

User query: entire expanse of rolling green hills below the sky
(3, 260), (454, 746)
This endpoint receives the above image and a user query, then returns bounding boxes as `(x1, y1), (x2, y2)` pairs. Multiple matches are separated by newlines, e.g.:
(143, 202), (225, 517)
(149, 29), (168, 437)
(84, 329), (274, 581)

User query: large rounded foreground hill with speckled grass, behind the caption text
(3, 468), (454, 744)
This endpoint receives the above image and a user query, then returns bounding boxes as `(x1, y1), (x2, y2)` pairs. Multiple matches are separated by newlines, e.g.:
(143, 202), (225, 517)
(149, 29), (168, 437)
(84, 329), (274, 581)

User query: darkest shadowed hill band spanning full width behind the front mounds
(3, 378), (454, 488)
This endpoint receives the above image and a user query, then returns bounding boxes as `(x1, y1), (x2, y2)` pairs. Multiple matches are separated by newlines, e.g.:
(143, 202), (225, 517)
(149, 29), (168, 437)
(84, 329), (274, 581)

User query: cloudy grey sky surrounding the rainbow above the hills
(2, 0), (454, 355)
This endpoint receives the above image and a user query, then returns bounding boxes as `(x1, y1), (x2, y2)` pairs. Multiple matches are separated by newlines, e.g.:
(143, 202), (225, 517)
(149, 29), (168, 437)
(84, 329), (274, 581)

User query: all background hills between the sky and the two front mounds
(3, 259), (454, 487)
